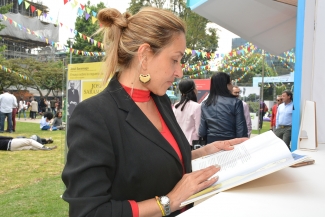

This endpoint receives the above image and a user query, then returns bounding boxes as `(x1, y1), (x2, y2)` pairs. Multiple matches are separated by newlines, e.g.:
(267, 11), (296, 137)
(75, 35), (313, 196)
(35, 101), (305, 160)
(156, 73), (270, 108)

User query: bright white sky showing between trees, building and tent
(32, 0), (239, 54)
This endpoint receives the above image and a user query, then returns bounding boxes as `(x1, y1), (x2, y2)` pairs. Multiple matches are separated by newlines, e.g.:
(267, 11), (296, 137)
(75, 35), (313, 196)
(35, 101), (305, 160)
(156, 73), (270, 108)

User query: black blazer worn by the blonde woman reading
(62, 78), (191, 217)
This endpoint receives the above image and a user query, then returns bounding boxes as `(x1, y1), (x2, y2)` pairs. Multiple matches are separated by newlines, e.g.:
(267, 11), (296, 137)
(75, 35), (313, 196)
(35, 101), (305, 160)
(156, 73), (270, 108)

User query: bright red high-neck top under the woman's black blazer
(122, 85), (185, 217)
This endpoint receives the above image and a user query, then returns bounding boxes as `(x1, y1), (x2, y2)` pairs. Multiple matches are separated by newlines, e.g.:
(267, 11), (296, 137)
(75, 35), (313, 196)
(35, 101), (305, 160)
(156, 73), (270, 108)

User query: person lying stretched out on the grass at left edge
(0, 136), (57, 151)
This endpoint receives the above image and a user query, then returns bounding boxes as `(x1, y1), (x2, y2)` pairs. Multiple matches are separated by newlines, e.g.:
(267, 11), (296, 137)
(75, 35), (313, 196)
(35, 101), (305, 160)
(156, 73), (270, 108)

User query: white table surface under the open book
(178, 144), (325, 217)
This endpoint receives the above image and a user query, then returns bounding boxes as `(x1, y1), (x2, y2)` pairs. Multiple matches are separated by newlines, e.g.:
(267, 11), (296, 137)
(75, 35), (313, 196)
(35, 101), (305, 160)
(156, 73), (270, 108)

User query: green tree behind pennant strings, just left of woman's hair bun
(67, 1), (106, 63)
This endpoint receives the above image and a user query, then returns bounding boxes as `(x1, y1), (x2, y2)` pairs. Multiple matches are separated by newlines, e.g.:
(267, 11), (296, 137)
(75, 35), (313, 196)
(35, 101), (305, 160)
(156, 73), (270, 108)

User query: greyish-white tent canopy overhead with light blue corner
(188, 0), (297, 55)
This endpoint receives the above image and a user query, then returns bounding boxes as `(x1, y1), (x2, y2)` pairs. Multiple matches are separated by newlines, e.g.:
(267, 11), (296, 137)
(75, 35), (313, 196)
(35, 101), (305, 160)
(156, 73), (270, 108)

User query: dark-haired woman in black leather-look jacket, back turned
(199, 72), (248, 143)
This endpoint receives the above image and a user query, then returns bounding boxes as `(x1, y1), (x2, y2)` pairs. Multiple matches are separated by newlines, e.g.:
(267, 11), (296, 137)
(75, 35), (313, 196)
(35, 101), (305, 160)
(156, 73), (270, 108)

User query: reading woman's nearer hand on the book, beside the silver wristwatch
(167, 166), (220, 212)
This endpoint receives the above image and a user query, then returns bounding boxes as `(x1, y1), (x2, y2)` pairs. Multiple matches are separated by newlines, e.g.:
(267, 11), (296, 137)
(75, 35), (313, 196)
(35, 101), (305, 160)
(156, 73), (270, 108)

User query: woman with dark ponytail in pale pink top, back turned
(173, 79), (201, 146)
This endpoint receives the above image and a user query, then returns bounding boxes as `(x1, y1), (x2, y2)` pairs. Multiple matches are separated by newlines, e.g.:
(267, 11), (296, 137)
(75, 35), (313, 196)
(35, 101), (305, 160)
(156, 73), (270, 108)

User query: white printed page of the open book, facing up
(192, 131), (292, 184)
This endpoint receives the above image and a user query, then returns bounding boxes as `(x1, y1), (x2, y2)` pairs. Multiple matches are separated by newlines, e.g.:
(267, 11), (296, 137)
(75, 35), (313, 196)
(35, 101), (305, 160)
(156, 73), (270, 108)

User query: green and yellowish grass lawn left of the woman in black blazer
(0, 121), (68, 217)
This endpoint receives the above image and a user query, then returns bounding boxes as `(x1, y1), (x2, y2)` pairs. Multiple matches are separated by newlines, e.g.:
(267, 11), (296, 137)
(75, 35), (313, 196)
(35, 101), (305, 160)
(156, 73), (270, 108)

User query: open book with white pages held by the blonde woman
(181, 131), (308, 206)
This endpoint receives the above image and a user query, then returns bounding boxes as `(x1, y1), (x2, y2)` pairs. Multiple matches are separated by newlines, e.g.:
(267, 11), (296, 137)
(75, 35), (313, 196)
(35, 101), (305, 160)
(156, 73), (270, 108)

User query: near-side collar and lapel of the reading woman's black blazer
(108, 78), (181, 163)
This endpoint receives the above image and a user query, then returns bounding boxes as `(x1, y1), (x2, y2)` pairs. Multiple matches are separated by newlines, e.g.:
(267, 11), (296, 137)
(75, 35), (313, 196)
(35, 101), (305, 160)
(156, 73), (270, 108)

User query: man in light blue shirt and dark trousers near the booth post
(274, 90), (293, 150)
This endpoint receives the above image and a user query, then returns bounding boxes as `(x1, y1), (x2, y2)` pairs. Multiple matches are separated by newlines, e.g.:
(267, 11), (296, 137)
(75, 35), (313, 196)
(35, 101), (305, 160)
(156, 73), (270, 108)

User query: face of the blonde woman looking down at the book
(143, 33), (186, 96)
